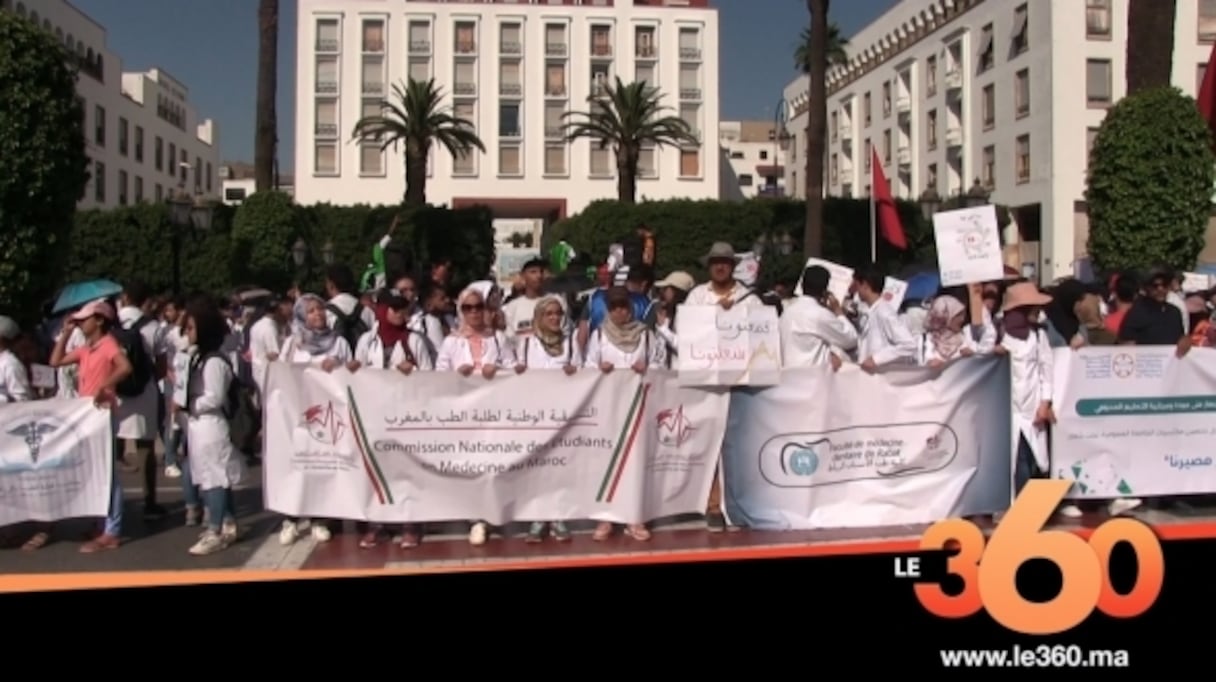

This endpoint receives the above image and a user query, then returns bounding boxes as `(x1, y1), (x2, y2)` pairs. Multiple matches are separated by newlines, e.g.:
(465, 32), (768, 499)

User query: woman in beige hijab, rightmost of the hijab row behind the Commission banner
(586, 287), (668, 541)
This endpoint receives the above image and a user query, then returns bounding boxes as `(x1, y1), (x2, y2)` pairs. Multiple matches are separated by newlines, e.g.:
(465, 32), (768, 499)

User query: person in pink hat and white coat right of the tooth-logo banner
(1001, 282), (1055, 494)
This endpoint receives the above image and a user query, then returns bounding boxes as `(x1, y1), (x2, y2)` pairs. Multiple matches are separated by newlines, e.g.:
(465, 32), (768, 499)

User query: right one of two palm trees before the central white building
(562, 77), (700, 204)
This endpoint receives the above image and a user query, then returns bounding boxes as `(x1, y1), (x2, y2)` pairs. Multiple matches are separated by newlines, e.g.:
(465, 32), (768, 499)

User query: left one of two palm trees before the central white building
(353, 78), (485, 205)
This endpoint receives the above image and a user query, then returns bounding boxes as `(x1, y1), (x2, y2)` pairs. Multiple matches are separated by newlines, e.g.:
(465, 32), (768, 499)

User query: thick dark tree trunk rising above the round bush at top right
(1126, 0), (1178, 95)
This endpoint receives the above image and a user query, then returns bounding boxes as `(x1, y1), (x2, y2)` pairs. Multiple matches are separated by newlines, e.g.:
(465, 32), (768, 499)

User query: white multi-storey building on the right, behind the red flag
(786, 0), (1216, 282)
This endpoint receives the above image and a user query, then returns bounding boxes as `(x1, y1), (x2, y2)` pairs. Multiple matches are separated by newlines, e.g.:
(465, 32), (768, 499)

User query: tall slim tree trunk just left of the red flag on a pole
(803, 0), (828, 257)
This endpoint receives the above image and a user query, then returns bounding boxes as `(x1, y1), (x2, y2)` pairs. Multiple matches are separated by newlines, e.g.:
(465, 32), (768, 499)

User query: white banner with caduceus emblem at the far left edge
(0, 398), (114, 526)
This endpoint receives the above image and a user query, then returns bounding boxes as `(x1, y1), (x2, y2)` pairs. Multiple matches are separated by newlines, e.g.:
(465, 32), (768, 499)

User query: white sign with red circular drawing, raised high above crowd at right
(933, 205), (1004, 287)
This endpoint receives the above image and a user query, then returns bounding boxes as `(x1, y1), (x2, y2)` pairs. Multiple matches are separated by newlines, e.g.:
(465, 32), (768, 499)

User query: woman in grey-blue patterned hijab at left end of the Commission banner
(278, 294), (353, 545)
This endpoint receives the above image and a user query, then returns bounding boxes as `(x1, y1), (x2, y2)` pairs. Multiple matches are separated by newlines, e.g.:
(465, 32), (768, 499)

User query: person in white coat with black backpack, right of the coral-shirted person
(111, 282), (167, 520)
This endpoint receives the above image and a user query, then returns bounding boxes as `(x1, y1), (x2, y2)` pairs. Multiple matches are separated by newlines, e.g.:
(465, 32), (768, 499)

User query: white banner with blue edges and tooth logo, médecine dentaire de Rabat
(722, 359), (1010, 530)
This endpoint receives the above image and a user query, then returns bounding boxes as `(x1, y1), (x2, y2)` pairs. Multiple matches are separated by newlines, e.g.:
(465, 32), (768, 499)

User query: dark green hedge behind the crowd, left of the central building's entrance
(60, 198), (495, 293)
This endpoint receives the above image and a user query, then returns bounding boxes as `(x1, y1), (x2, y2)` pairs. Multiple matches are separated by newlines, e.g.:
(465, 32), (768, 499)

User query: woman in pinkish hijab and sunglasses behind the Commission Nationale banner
(435, 286), (523, 545)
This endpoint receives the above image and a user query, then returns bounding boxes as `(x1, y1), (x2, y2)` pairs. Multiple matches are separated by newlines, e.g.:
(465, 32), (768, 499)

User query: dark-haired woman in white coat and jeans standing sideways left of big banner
(185, 300), (244, 556)
